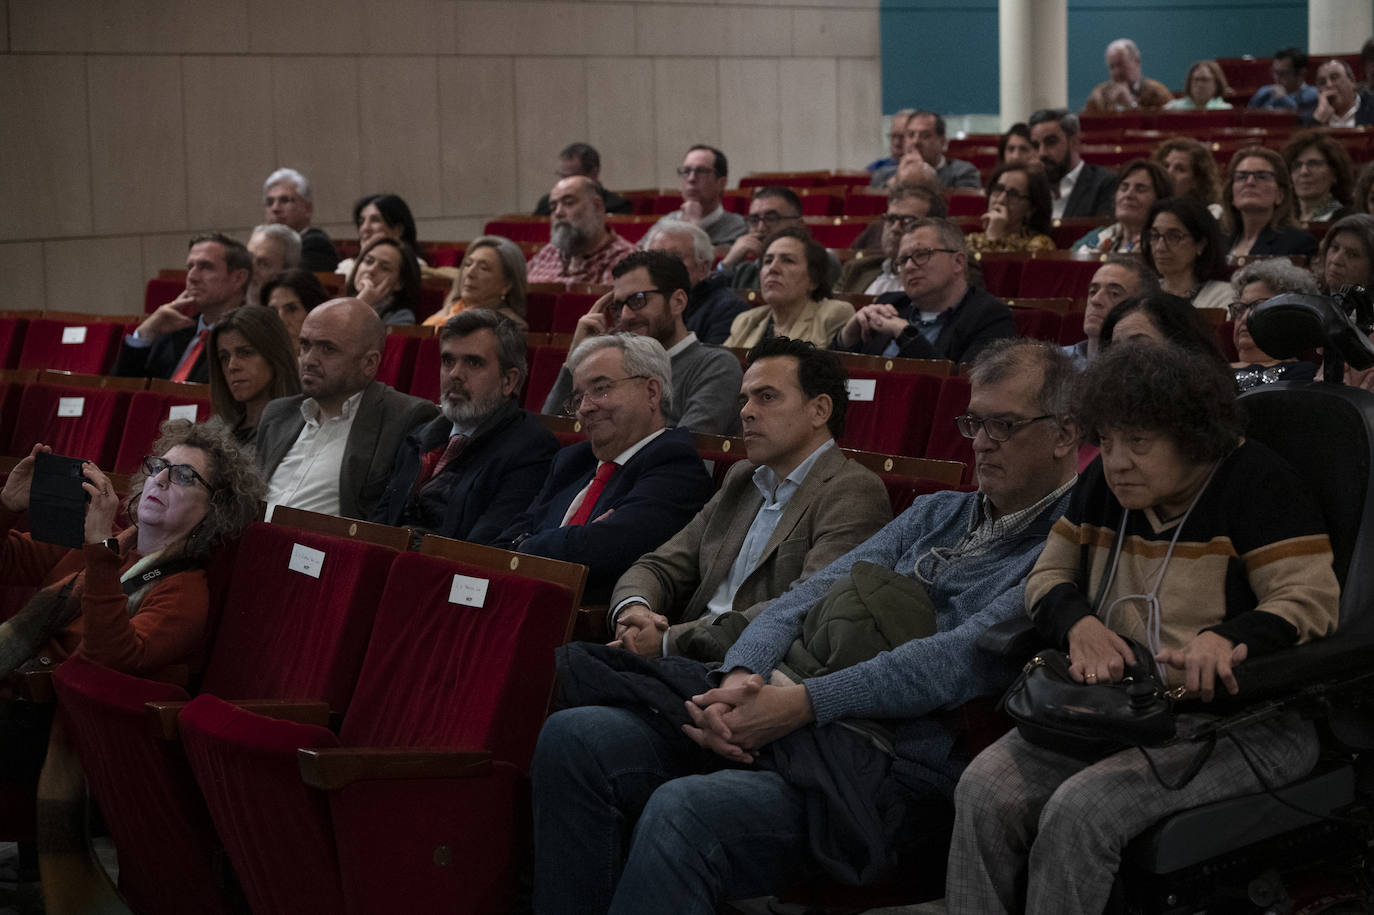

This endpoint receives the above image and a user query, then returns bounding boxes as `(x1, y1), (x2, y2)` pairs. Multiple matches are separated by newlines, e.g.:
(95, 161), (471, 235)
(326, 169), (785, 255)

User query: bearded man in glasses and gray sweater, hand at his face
(544, 251), (742, 436)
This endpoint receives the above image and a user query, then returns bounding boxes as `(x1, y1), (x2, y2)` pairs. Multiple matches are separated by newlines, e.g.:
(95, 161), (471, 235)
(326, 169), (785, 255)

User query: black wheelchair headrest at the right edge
(1249, 286), (1374, 370)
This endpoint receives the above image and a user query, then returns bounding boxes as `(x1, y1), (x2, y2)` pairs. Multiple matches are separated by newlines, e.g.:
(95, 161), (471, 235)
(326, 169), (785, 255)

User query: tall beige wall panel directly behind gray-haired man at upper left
(267, 58), (363, 223)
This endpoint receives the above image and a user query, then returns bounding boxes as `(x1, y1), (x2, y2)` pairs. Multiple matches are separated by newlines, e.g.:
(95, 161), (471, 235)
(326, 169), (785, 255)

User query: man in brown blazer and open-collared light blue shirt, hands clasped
(609, 337), (892, 655)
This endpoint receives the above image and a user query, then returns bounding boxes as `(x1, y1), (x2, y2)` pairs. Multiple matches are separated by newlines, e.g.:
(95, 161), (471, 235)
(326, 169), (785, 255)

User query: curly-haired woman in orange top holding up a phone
(0, 419), (264, 684)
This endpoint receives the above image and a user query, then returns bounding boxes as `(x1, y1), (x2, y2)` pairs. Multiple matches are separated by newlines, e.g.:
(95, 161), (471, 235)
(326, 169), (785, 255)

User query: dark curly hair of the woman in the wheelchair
(1077, 341), (1245, 463)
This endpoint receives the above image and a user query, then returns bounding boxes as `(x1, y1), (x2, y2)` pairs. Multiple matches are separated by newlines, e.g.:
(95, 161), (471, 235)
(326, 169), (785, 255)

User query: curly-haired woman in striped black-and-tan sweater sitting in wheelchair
(947, 342), (1338, 915)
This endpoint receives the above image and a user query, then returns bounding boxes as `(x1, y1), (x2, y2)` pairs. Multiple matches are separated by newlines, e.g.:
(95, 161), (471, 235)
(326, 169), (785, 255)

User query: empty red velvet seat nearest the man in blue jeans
(181, 554), (581, 912)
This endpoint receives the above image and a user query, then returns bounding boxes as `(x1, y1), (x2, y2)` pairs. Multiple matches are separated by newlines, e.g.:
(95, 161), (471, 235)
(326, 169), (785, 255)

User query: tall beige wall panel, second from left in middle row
(87, 56), (186, 233)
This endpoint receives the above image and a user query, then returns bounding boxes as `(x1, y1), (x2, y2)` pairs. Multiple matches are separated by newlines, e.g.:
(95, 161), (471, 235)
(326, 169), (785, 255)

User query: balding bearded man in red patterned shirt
(526, 174), (635, 286)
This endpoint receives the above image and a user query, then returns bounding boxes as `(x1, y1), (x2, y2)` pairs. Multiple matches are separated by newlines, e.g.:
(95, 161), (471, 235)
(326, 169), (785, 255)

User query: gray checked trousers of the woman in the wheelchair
(945, 713), (1318, 915)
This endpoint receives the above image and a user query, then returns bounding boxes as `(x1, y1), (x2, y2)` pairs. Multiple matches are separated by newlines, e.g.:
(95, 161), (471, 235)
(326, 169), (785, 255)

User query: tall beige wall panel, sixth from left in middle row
(438, 58), (519, 214)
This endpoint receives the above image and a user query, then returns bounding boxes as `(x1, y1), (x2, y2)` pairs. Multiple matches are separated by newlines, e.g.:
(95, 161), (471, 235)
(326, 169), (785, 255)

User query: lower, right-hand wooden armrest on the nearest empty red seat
(297, 746), (492, 791)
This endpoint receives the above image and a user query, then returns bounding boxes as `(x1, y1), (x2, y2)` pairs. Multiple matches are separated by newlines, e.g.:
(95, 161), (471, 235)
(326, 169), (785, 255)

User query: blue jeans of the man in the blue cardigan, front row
(530, 706), (811, 915)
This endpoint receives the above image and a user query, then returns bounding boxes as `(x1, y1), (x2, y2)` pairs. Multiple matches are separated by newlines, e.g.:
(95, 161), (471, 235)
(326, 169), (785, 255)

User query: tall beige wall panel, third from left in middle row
(181, 56), (276, 229)
